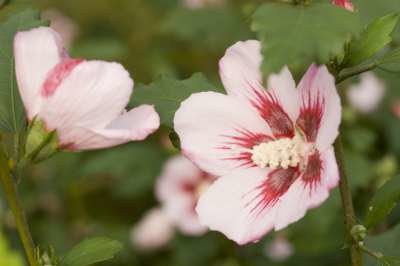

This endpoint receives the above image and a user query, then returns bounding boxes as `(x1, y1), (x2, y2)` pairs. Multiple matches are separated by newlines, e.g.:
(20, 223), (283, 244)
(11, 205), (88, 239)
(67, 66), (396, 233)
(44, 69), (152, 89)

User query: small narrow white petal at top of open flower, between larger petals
(268, 66), (300, 121)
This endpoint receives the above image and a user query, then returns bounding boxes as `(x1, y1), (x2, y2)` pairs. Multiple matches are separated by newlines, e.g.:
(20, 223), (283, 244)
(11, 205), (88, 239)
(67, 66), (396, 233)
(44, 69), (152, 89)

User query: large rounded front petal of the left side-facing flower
(39, 61), (133, 134)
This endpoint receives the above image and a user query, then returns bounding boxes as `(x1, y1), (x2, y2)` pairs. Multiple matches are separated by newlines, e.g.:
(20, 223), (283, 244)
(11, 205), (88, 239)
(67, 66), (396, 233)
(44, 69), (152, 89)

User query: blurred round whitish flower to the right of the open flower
(347, 72), (385, 113)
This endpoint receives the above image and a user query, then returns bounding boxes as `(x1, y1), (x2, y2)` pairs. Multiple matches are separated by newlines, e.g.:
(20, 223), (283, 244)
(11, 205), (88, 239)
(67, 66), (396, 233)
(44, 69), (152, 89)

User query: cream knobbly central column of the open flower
(251, 134), (315, 169)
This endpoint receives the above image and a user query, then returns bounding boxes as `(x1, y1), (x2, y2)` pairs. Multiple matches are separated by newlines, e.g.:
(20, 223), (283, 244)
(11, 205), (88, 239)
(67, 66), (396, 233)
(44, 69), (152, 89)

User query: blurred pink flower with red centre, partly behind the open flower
(156, 156), (214, 235)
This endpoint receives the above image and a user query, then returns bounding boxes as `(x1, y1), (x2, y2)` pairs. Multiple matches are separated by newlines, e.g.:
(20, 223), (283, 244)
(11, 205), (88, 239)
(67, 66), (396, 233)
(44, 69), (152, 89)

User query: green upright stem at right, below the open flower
(334, 136), (363, 266)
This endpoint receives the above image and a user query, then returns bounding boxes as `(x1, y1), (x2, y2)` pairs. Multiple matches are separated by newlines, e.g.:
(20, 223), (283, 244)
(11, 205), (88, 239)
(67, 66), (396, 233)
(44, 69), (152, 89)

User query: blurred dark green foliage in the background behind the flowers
(0, 0), (400, 266)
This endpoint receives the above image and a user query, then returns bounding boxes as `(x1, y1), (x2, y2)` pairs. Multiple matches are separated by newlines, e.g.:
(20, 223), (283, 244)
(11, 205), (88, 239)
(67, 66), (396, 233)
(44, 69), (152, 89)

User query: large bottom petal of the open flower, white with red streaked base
(196, 168), (297, 244)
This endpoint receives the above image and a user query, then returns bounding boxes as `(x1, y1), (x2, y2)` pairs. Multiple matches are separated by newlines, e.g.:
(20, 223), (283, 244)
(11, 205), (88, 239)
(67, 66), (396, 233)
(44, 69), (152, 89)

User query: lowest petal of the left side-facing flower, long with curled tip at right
(57, 105), (160, 150)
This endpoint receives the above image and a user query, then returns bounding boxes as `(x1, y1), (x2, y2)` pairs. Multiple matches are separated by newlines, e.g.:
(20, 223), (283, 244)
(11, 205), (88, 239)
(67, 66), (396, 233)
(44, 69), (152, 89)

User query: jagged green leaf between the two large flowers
(132, 73), (217, 128)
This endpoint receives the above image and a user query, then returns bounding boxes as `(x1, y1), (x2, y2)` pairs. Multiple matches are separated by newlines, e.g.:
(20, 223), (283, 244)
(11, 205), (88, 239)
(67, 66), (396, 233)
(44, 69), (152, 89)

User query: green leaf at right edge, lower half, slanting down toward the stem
(364, 177), (400, 228)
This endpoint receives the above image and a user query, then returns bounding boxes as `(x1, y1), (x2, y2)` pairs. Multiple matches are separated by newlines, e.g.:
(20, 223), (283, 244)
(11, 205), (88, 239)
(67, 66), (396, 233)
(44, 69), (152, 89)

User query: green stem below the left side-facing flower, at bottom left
(0, 151), (38, 266)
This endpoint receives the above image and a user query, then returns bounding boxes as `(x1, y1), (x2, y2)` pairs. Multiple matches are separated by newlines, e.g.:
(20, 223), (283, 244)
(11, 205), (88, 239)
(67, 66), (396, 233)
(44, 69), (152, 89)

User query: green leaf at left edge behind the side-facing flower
(0, 9), (45, 133)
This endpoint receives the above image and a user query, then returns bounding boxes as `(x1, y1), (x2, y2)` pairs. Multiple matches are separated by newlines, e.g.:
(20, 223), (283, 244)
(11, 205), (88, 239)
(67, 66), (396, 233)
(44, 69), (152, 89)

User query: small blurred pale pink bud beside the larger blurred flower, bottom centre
(131, 208), (174, 251)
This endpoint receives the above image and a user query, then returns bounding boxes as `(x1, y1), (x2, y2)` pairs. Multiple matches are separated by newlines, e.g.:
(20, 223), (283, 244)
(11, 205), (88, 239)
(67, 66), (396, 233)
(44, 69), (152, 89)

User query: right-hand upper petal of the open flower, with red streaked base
(296, 65), (341, 151)
